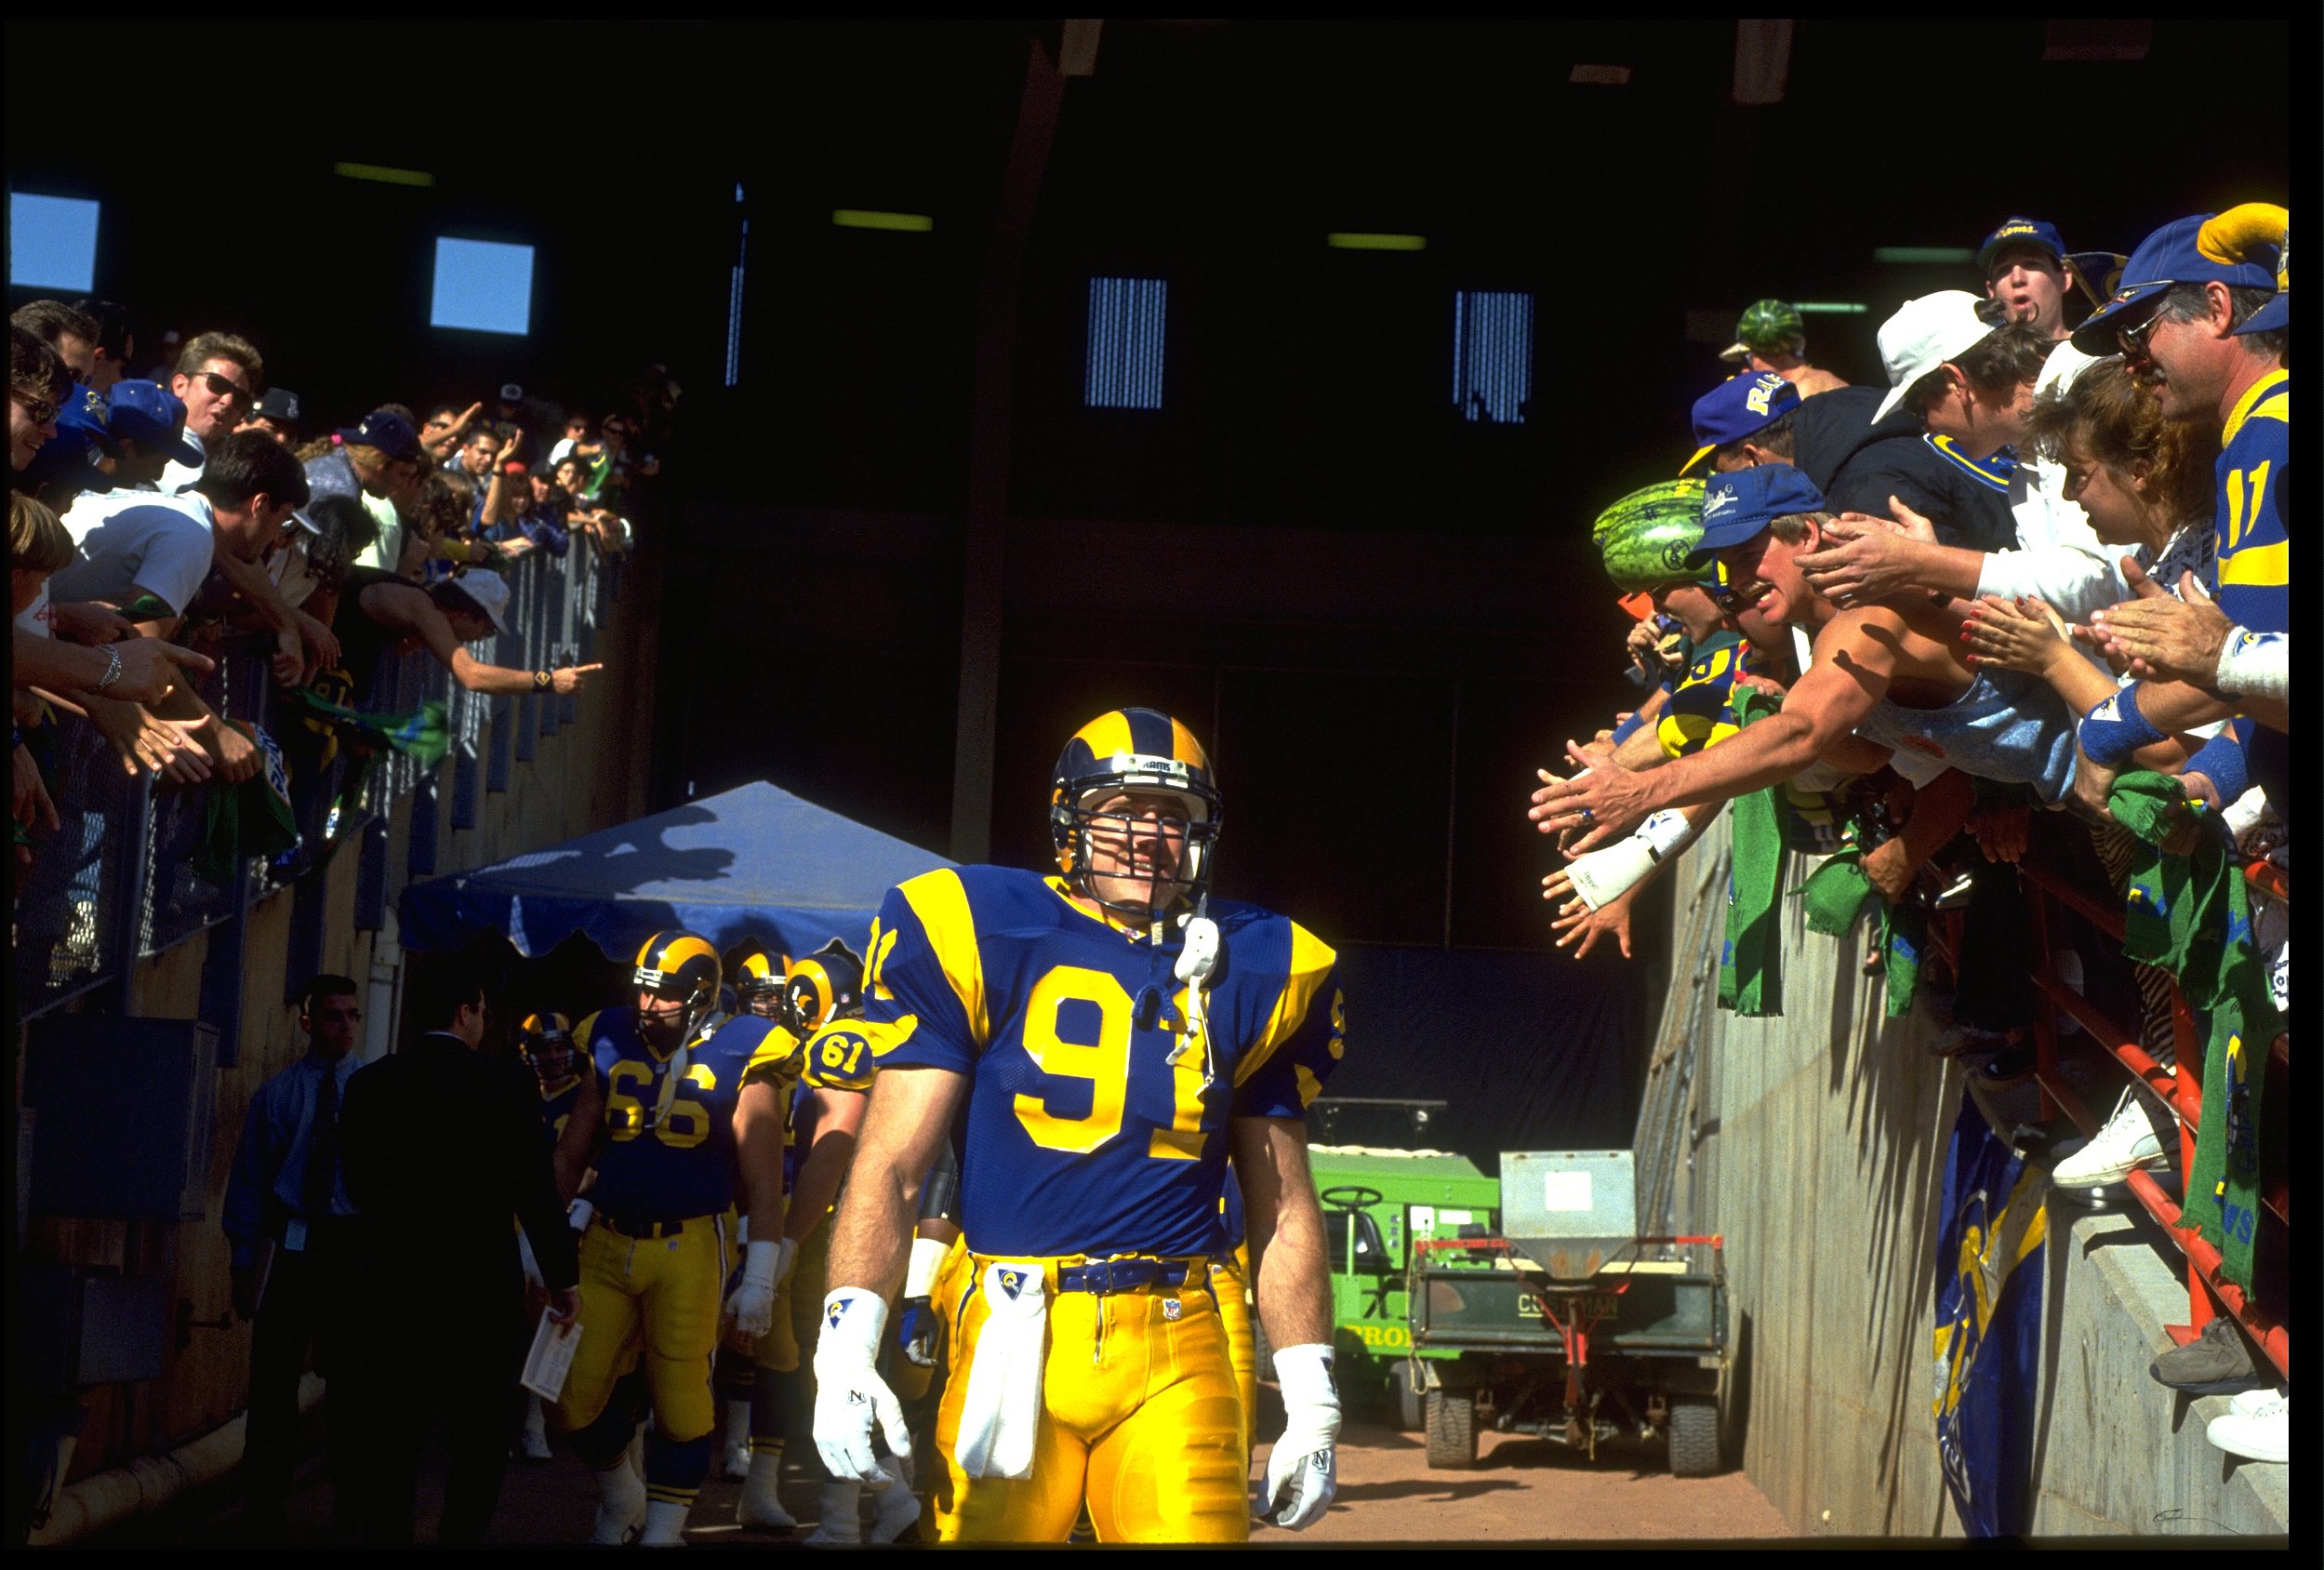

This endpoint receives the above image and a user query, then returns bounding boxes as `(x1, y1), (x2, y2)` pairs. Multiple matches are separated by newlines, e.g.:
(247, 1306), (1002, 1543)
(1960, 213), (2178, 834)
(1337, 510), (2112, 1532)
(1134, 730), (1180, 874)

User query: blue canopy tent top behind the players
(400, 781), (953, 961)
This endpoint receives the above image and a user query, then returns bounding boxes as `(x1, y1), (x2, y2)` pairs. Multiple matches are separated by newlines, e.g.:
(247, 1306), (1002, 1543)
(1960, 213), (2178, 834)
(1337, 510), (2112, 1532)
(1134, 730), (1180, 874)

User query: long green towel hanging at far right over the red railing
(2105, 770), (2285, 1291)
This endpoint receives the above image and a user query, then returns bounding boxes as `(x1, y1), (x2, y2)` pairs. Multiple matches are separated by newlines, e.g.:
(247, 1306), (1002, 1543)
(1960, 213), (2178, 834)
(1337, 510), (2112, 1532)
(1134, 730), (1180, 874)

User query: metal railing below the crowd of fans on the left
(11, 539), (623, 1021)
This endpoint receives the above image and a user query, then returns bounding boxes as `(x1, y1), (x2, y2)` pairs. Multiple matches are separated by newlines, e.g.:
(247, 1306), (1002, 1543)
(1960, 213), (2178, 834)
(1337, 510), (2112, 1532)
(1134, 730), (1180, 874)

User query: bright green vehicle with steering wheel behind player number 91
(1301, 1098), (1501, 1430)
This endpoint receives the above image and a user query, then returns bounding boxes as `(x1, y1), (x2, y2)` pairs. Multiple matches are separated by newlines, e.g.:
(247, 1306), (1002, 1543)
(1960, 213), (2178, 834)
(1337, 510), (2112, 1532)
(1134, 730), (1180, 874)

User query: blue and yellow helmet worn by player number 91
(1048, 710), (1225, 921)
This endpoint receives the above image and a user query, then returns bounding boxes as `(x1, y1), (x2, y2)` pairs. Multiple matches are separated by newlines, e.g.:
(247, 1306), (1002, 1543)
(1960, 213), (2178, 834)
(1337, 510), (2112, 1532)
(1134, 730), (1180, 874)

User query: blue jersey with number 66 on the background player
(583, 1009), (772, 1221)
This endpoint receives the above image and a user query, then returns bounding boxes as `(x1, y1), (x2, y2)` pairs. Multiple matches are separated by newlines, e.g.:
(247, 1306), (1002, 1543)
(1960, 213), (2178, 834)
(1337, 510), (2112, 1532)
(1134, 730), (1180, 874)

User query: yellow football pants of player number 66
(558, 1217), (732, 1444)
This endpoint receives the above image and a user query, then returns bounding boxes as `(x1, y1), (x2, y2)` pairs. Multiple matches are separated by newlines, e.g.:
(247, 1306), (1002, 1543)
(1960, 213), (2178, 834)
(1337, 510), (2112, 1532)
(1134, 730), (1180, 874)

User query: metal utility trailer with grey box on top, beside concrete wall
(1406, 1151), (1727, 1477)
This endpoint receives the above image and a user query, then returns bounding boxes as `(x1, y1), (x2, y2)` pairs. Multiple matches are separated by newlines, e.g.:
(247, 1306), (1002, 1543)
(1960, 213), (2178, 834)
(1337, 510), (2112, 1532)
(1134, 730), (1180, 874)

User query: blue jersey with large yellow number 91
(860, 868), (1343, 1258)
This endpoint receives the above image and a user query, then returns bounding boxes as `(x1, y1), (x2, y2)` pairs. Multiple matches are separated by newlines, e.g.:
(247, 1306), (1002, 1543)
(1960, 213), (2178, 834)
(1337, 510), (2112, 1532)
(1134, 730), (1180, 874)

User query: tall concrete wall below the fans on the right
(1664, 817), (2290, 1537)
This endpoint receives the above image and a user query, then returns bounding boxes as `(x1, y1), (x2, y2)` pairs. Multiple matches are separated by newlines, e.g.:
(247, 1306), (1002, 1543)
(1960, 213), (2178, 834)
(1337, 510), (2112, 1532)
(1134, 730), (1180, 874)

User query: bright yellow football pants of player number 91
(935, 1251), (1250, 1542)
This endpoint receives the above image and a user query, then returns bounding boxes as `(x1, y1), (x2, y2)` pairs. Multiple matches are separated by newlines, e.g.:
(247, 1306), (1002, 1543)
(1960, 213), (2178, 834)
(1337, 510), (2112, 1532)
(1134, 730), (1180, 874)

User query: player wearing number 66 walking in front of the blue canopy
(558, 933), (783, 1544)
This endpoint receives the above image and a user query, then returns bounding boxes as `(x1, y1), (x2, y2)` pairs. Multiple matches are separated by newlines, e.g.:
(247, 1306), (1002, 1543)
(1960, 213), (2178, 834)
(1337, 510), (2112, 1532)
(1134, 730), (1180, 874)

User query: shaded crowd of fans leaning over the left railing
(9, 300), (679, 865)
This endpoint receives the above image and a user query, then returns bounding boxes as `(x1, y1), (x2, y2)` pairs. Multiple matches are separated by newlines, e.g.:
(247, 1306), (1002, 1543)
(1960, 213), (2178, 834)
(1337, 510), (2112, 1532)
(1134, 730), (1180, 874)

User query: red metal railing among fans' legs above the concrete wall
(1946, 863), (2291, 1379)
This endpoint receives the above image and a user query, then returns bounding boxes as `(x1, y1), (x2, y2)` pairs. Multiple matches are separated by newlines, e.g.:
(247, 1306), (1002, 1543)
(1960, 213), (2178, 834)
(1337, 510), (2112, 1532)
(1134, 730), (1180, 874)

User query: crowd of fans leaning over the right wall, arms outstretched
(1529, 203), (2291, 1460)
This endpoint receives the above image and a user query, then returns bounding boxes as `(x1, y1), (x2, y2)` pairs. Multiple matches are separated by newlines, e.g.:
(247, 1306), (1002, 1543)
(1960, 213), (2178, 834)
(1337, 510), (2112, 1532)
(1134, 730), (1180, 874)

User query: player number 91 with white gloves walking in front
(814, 710), (1341, 1542)
